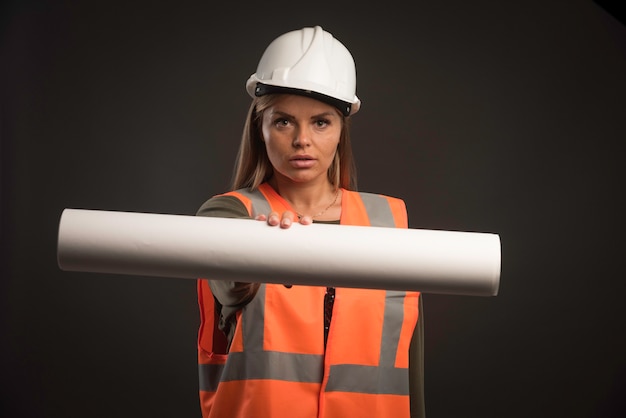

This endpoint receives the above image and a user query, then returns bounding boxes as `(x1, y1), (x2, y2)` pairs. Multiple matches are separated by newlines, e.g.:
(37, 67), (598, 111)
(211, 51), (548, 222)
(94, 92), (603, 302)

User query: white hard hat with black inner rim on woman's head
(246, 26), (361, 116)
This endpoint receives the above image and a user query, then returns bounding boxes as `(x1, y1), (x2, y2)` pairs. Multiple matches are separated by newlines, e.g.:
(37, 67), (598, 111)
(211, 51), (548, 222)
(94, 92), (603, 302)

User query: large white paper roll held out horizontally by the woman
(57, 209), (501, 296)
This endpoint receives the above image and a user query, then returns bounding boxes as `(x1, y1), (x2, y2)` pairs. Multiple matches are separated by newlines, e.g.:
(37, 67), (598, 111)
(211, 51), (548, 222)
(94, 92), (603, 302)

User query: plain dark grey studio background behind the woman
(0, 0), (626, 418)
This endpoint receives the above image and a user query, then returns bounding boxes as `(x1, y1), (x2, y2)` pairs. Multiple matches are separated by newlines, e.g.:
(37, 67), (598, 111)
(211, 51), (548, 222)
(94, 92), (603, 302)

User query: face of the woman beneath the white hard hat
(262, 95), (342, 187)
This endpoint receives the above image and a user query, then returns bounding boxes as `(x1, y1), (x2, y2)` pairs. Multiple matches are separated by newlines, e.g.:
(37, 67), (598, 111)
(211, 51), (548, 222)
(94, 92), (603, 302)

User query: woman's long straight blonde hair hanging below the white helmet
(232, 94), (356, 190)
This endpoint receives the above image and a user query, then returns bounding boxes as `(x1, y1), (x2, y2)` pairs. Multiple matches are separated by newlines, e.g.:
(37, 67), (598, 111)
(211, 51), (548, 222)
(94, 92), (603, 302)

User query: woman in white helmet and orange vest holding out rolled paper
(198, 26), (424, 418)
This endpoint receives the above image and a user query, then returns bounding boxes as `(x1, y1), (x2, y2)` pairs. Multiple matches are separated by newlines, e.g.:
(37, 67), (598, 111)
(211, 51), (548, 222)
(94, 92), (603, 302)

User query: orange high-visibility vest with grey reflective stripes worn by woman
(198, 183), (419, 418)
